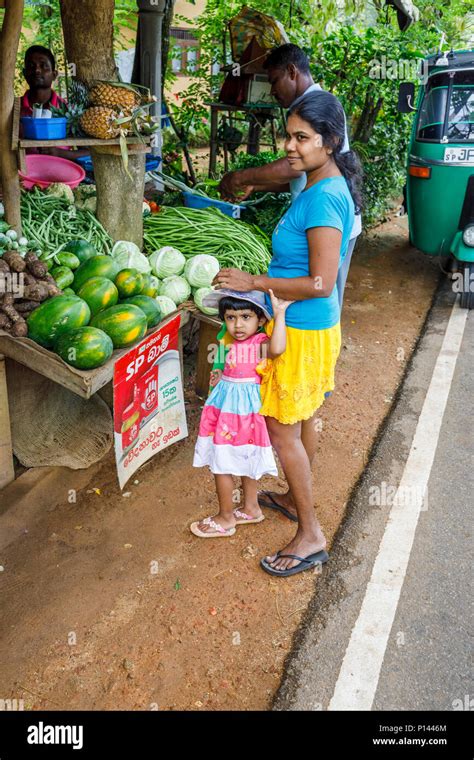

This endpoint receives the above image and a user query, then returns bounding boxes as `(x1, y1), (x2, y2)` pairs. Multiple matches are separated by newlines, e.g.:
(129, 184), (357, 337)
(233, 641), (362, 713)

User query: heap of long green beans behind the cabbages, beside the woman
(143, 206), (271, 274)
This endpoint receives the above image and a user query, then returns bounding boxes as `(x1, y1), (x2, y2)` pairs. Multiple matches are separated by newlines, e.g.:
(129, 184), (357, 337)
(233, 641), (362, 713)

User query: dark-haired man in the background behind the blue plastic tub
(20, 45), (65, 116)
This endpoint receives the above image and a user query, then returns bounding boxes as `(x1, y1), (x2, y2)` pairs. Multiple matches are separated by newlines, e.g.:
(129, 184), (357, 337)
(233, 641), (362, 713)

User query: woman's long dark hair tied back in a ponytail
(289, 90), (362, 211)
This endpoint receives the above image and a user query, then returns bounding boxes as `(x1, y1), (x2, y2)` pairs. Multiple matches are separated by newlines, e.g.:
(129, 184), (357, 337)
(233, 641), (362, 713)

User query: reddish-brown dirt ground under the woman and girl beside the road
(0, 217), (439, 710)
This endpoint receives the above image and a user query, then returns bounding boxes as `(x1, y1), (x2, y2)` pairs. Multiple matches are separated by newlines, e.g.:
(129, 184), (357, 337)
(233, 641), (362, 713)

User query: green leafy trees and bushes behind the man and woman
(184, 0), (472, 225)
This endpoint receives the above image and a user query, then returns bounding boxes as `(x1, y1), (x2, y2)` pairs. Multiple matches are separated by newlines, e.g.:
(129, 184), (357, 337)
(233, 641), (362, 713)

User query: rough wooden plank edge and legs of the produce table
(0, 309), (190, 490)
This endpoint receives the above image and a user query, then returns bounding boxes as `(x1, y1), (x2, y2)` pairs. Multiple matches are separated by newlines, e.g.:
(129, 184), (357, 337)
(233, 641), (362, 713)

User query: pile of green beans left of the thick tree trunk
(21, 188), (113, 253)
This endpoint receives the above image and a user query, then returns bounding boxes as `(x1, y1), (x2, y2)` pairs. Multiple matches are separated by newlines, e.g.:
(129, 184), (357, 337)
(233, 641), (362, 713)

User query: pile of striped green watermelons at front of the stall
(28, 241), (165, 370)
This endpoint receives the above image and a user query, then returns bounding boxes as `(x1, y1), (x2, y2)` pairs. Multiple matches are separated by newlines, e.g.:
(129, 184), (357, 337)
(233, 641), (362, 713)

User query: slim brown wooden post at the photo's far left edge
(0, 0), (23, 234)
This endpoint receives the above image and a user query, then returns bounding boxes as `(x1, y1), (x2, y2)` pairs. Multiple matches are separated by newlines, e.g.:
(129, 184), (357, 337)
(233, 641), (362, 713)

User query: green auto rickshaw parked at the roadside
(398, 50), (474, 309)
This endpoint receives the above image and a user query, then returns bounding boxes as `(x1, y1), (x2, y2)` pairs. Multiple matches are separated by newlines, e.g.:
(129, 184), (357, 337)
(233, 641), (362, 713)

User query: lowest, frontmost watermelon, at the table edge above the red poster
(54, 327), (114, 370)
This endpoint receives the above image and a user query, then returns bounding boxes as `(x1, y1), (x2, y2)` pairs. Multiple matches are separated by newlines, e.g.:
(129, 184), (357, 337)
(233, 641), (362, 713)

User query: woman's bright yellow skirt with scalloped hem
(257, 320), (341, 425)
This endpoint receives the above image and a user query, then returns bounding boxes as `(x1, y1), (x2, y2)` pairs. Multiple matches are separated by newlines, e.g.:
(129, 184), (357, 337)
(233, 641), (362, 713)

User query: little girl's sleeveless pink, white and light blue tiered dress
(193, 333), (278, 480)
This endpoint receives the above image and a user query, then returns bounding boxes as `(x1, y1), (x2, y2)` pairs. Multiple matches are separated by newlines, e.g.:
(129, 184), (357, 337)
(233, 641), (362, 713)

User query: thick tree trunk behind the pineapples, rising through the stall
(61, 0), (145, 249)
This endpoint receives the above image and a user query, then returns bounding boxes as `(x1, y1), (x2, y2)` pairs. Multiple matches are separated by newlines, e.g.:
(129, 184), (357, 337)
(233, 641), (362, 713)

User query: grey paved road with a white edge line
(274, 284), (474, 711)
